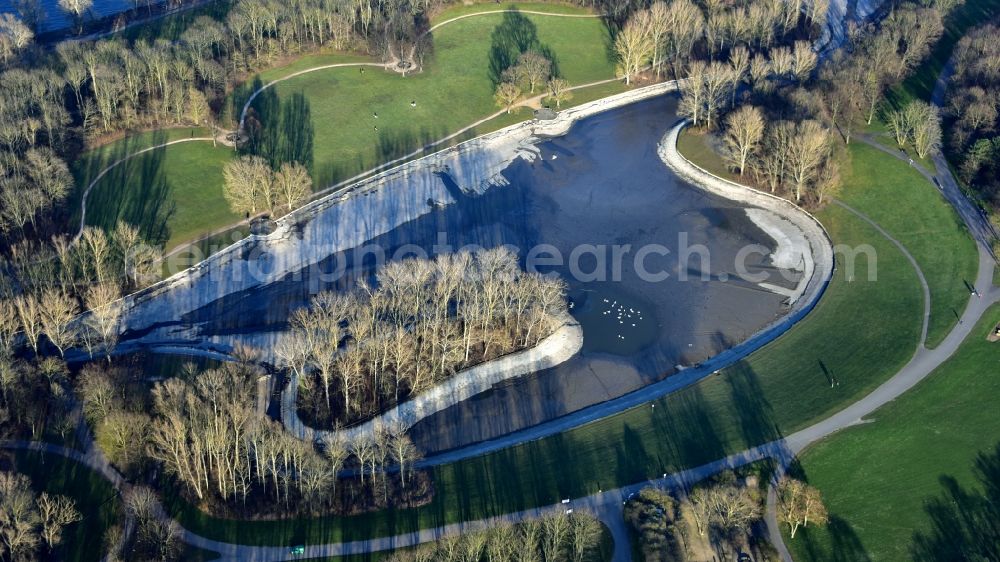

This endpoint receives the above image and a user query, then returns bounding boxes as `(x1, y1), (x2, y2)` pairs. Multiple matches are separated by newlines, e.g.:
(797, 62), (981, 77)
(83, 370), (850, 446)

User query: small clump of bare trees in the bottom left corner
(0, 472), (81, 560)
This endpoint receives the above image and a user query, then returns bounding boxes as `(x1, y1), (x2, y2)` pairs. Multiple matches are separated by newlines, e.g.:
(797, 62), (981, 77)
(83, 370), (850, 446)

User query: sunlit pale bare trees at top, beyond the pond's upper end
(614, 0), (829, 85)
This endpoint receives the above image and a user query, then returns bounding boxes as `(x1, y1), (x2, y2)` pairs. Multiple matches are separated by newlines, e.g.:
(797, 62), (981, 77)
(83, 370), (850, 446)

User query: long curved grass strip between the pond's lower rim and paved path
(169, 138), (921, 544)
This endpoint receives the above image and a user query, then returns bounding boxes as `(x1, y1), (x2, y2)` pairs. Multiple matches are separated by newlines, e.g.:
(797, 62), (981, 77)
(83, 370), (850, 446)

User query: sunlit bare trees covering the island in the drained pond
(286, 247), (565, 427)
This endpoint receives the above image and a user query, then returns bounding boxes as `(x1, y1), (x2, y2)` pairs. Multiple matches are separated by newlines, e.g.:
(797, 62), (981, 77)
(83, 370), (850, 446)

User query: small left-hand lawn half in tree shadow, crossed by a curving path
(74, 129), (240, 249)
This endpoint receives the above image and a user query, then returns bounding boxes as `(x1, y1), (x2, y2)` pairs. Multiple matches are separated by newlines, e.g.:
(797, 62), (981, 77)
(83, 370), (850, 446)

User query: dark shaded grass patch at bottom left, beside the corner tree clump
(4, 451), (121, 562)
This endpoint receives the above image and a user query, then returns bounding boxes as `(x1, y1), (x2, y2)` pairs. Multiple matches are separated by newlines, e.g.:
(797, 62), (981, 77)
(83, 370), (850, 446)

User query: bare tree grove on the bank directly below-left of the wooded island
(92, 352), (426, 515)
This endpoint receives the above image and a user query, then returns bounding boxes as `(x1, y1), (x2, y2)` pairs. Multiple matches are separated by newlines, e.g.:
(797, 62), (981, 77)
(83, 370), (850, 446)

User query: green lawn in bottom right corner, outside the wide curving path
(786, 306), (1000, 560)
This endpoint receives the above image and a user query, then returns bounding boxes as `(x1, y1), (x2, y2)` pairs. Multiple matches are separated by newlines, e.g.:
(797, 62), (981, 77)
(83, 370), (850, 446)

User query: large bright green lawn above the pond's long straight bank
(245, 6), (614, 187)
